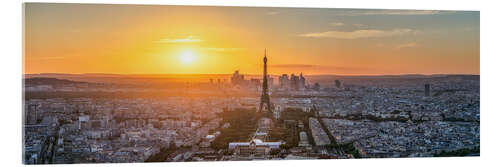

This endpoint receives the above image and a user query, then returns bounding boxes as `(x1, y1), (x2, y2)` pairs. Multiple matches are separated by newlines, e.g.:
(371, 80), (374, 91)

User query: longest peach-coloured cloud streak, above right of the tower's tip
(299, 29), (416, 39)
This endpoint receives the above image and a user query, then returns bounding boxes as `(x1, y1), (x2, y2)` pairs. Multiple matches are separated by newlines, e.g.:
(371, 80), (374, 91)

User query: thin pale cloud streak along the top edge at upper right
(337, 10), (455, 16)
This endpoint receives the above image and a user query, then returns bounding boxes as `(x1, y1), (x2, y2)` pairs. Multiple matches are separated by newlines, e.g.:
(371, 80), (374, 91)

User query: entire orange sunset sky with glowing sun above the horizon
(24, 3), (479, 75)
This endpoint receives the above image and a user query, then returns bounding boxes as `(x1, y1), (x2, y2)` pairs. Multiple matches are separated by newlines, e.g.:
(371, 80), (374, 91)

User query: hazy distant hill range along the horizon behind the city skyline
(24, 73), (479, 86)
